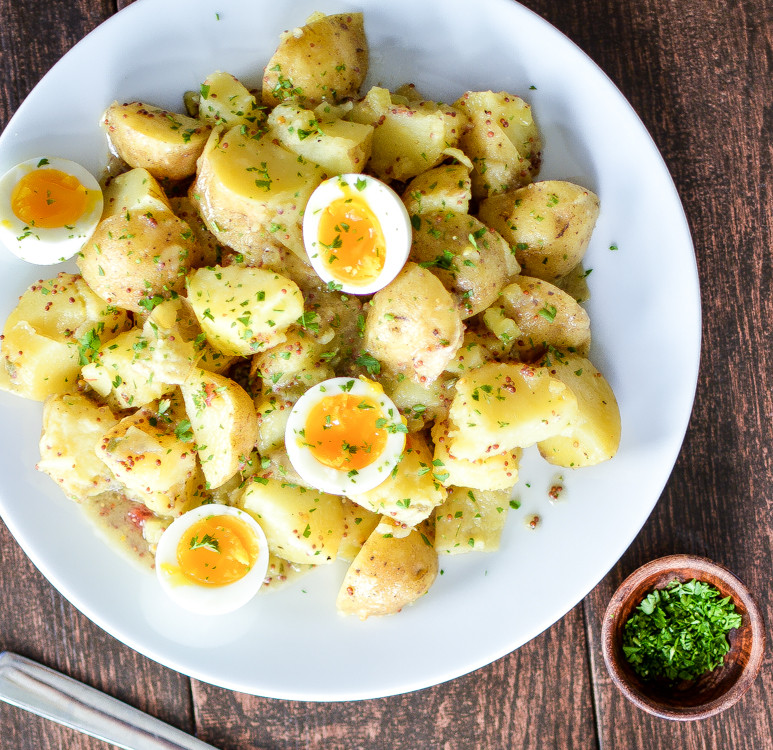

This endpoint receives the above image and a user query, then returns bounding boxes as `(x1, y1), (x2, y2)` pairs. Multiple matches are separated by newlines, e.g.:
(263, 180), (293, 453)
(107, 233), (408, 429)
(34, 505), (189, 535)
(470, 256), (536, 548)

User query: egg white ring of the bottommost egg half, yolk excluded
(156, 503), (269, 615)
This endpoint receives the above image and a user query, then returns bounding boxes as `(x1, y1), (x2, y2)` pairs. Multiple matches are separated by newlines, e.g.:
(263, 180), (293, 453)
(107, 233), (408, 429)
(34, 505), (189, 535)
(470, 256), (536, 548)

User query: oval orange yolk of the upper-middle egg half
(318, 190), (386, 285)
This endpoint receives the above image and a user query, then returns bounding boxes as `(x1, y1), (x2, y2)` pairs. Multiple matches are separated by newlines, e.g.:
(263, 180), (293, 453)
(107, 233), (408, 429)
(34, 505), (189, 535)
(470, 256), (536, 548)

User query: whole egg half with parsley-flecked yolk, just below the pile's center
(285, 378), (407, 495)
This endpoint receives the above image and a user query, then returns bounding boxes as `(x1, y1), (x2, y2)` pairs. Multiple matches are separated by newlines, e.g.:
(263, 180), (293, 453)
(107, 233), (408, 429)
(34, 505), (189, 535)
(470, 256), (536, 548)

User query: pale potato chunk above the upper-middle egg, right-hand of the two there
(348, 88), (466, 180)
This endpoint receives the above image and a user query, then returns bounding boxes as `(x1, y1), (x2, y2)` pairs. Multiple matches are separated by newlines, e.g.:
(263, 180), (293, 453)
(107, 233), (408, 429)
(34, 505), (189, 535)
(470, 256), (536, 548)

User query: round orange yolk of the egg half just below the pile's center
(304, 393), (387, 472)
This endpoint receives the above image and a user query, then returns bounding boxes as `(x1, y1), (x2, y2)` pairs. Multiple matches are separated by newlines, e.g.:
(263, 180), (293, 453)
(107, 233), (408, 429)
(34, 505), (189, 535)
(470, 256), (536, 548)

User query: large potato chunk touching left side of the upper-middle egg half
(190, 127), (324, 260)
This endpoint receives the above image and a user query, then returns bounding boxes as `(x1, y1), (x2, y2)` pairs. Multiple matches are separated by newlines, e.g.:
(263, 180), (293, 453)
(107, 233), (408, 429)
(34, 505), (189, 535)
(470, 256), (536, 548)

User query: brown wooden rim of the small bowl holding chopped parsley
(601, 554), (766, 721)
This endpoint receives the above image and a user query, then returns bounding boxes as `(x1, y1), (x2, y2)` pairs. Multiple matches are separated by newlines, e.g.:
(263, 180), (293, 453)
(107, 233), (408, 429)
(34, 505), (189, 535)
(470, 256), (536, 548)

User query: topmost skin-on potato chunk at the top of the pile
(263, 13), (368, 107)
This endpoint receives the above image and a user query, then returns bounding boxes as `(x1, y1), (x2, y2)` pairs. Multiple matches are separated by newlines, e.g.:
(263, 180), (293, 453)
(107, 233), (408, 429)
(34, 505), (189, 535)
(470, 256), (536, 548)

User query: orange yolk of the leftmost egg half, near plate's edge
(11, 169), (91, 229)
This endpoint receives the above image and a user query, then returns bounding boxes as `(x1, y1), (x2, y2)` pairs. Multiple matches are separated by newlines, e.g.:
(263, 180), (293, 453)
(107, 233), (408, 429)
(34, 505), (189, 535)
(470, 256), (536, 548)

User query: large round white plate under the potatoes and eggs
(0, 0), (700, 700)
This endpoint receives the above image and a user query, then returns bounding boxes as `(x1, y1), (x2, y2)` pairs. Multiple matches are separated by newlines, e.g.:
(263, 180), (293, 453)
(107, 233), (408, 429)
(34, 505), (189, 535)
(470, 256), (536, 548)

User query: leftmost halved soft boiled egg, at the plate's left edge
(0, 156), (102, 265)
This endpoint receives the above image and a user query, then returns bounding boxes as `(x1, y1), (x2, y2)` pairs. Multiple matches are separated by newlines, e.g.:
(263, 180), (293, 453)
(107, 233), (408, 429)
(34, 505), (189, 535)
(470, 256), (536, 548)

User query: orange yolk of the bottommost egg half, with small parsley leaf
(177, 516), (258, 586)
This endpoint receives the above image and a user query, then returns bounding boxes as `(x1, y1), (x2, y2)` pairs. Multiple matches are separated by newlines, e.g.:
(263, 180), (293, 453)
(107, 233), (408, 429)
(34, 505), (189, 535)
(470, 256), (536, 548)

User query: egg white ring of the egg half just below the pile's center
(285, 378), (405, 495)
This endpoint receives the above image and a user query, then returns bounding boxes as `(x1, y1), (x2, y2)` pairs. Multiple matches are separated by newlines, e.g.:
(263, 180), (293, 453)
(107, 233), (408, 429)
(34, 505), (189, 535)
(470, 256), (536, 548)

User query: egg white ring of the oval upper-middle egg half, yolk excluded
(303, 174), (413, 294)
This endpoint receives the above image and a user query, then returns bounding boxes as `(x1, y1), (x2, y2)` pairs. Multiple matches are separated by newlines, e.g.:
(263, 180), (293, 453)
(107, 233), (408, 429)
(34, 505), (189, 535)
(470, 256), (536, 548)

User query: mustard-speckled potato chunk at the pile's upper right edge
(454, 91), (542, 198)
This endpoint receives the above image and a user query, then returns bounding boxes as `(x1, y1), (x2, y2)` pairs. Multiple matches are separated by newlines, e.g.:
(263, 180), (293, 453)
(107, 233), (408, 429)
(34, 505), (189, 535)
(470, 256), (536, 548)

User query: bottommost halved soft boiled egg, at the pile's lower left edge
(156, 504), (268, 615)
